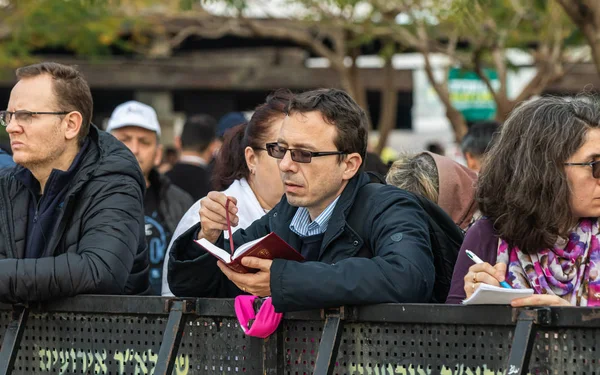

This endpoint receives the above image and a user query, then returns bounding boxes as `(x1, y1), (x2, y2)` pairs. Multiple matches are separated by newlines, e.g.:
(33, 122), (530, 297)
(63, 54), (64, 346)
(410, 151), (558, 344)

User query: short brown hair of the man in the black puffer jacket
(16, 62), (94, 145)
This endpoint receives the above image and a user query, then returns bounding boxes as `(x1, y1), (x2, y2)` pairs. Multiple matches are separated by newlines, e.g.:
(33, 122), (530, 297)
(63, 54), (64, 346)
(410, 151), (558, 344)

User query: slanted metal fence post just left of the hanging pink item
(154, 300), (194, 375)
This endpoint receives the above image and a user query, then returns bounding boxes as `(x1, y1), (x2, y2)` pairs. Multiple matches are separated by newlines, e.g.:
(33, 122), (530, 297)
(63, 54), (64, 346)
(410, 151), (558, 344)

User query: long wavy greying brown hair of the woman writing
(477, 97), (600, 253)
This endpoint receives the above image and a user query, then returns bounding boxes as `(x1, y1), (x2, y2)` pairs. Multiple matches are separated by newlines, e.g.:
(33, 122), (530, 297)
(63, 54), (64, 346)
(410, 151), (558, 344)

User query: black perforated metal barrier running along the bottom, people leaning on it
(0, 296), (600, 375)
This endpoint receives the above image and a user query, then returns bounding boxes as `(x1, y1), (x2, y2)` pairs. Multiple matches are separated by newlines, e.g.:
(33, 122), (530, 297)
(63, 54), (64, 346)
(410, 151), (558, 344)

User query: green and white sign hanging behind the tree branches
(448, 68), (500, 121)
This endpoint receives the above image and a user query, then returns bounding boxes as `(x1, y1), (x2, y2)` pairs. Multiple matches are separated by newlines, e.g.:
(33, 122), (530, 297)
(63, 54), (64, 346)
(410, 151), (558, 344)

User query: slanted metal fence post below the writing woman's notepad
(505, 307), (552, 375)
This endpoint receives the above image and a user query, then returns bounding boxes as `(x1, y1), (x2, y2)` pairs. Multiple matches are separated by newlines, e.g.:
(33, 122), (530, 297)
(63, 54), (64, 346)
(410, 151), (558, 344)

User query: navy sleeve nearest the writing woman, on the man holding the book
(271, 192), (435, 312)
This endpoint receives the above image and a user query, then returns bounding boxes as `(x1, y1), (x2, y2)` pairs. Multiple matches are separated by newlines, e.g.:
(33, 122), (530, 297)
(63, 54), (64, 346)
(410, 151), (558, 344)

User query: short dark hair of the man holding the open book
(287, 89), (368, 169)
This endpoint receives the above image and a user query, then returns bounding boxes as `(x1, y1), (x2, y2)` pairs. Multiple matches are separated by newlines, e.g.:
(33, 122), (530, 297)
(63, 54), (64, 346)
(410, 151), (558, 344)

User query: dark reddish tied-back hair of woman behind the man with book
(212, 89), (293, 190)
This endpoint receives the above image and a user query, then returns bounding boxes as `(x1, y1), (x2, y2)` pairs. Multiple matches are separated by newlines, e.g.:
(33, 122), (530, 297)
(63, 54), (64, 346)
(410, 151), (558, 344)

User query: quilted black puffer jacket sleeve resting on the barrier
(0, 177), (145, 303)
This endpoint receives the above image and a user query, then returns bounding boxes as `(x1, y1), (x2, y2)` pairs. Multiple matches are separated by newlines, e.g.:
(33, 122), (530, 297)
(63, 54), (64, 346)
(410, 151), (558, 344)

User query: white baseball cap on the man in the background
(106, 100), (160, 137)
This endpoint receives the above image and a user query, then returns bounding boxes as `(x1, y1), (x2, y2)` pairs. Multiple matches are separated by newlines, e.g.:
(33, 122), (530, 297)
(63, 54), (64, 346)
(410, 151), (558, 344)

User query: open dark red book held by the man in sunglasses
(195, 232), (304, 273)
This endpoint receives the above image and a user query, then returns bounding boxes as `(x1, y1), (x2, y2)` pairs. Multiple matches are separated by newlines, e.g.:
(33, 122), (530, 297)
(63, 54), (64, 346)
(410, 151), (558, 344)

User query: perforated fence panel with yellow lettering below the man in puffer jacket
(13, 313), (166, 375)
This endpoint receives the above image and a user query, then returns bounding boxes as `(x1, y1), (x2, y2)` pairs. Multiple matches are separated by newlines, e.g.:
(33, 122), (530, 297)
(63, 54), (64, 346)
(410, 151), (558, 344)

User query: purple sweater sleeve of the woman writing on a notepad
(446, 218), (498, 304)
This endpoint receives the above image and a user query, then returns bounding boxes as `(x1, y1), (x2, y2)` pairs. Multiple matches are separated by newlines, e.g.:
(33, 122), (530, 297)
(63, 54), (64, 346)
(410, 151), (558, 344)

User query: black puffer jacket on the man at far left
(0, 126), (149, 303)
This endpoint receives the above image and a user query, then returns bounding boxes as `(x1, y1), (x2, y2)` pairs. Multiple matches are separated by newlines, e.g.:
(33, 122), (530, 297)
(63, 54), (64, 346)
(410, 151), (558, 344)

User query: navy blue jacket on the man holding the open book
(168, 174), (435, 312)
